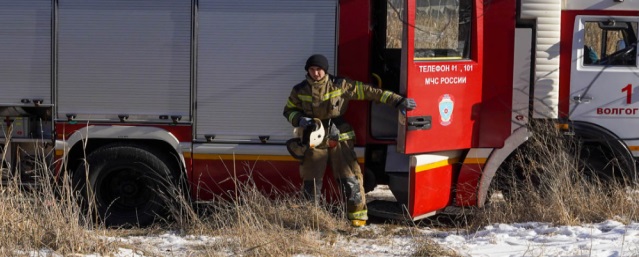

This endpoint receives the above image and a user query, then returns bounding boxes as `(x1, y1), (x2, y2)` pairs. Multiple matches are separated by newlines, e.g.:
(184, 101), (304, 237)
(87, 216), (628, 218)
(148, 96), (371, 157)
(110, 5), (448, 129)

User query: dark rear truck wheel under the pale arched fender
(73, 143), (172, 227)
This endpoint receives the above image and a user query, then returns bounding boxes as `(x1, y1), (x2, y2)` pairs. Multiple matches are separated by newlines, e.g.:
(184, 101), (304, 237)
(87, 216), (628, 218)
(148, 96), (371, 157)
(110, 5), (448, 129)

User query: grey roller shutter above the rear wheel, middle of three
(57, 0), (191, 121)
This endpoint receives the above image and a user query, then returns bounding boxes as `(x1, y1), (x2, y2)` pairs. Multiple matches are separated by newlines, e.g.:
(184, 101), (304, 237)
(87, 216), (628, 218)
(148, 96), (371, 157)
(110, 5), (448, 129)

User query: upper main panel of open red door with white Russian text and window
(398, 0), (482, 154)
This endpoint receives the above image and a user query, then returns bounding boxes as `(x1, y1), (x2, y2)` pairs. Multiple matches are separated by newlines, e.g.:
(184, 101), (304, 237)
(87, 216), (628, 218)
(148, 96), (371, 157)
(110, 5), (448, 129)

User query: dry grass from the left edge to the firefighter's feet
(0, 131), (352, 256)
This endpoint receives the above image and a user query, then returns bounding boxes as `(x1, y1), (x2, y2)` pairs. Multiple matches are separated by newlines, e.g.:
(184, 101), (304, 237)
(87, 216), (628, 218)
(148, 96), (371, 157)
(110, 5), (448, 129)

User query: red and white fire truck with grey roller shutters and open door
(0, 0), (639, 225)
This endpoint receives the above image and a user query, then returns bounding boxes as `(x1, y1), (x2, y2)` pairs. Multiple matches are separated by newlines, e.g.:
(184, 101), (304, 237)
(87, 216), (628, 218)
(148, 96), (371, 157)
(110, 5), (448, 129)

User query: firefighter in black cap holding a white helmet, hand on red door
(284, 54), (416, 227)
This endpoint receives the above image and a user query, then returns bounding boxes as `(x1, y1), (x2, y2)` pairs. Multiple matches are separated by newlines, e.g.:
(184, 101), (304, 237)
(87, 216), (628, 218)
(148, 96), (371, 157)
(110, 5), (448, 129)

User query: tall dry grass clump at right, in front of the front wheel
(473, 122), (639, 225)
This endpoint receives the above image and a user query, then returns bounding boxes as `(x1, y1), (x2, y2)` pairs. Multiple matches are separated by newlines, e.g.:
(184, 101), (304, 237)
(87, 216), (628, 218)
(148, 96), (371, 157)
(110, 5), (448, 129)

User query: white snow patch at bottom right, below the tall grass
(434, 221), (639, 256)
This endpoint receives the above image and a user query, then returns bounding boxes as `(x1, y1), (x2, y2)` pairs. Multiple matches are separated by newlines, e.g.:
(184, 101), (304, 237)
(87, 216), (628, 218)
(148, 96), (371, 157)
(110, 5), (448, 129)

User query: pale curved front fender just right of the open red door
(477, 126), (530, 208)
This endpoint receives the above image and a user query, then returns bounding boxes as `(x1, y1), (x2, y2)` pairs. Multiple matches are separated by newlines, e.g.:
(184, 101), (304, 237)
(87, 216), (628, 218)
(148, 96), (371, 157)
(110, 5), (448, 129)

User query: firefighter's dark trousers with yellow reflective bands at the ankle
(300, 140), (368, 220)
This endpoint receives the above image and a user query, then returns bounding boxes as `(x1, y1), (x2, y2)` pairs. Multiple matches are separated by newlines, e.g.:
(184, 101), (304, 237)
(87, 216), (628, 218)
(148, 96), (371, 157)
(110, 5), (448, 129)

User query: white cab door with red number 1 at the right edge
(569, 16), (639, 144)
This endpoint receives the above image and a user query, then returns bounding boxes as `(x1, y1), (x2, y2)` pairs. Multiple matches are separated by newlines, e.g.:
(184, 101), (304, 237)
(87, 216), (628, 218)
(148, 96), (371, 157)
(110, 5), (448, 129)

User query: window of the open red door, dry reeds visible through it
(414, 0), (472, 61)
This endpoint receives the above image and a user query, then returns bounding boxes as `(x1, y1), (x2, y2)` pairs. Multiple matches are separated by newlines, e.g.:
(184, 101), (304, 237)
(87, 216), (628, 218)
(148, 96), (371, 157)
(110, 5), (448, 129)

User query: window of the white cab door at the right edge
(582, 20), (637, 66)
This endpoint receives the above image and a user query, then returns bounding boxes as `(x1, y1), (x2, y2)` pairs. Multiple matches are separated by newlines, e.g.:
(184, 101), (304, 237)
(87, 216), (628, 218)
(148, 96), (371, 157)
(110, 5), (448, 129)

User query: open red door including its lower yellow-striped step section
(397, 0), (482, 219)
